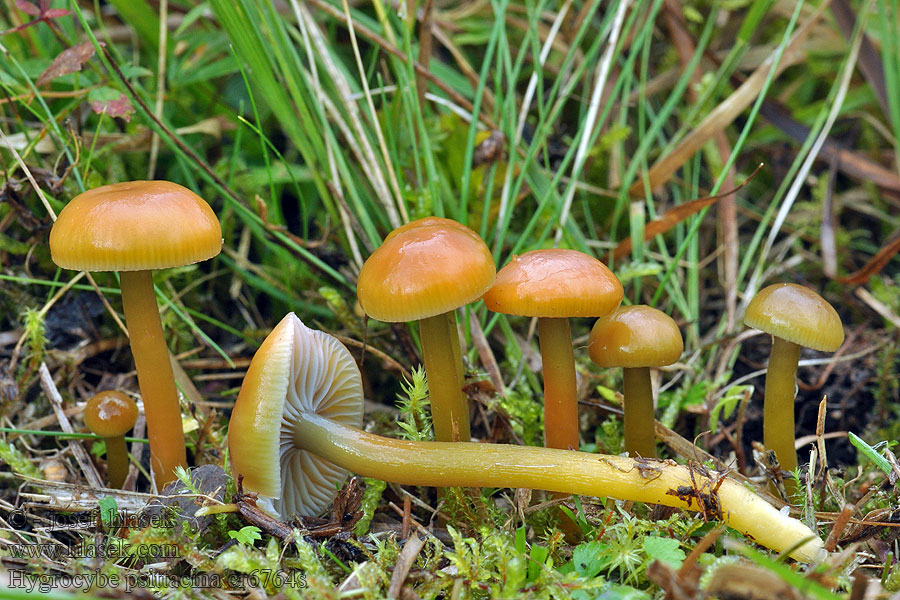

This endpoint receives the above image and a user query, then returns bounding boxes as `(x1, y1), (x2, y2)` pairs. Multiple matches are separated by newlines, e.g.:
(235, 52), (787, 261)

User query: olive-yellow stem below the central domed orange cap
(419, 314), (472, 442)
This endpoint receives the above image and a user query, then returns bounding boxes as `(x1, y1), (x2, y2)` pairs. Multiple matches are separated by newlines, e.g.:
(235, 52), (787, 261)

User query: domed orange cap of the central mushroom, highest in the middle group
(356, 217), (497, 322)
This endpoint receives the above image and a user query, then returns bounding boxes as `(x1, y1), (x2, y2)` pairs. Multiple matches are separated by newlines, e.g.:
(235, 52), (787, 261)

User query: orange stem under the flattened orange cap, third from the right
(538, 317), (578, 450)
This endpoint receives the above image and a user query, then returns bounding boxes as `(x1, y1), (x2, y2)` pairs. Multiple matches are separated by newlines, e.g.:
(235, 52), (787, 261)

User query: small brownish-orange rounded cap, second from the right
(588, 304), (684, 369)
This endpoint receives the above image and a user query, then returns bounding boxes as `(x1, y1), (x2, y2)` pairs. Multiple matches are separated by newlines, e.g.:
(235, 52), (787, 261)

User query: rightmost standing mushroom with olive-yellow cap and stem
(744, 283), (844, 494)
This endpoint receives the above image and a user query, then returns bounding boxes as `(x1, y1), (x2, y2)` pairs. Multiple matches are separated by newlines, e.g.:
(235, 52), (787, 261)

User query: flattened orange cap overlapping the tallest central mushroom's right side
(484, 248), (624, 317)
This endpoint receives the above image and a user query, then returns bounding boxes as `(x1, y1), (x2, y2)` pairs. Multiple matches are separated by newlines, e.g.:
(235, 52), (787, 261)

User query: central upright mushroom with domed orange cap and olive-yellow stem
(356, 217), (496, 442)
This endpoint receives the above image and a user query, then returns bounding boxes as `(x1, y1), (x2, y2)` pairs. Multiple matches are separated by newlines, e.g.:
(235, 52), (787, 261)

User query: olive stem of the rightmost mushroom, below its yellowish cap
(763, 336), (801, 498)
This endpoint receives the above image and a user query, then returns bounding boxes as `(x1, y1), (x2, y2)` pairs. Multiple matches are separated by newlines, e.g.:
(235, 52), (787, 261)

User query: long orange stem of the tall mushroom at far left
(119, 271), (187, 490)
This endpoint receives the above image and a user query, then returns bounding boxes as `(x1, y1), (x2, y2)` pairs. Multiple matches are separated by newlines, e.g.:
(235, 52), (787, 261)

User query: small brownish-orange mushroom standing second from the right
(588, 305), (684, 458)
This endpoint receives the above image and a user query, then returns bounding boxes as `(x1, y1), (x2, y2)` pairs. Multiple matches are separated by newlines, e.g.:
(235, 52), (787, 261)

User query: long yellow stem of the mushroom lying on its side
(293, 411), (824, 562)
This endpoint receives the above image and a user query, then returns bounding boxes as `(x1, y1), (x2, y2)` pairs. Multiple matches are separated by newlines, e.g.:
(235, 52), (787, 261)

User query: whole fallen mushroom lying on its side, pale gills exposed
(228, 313), (824, 561)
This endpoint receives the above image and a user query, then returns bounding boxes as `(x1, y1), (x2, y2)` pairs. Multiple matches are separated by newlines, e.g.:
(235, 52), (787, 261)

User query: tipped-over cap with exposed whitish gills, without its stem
(228, 313), (363, 518)
